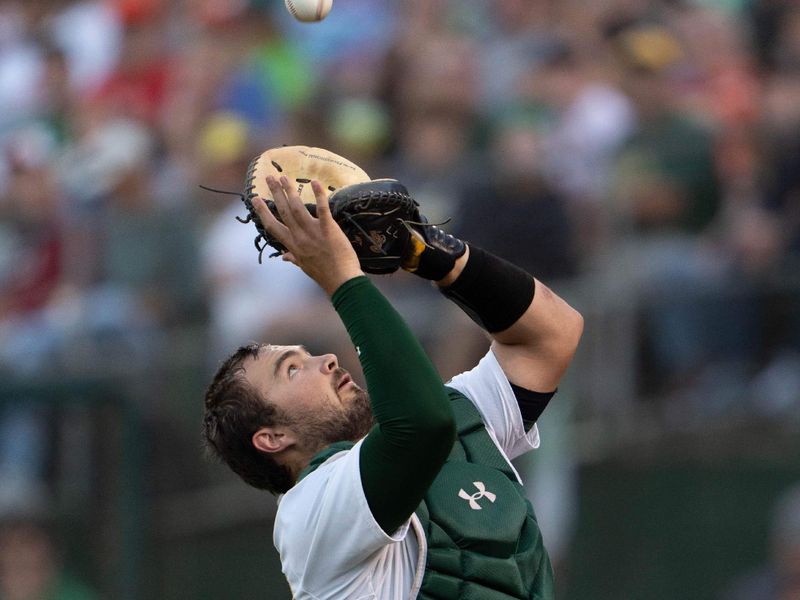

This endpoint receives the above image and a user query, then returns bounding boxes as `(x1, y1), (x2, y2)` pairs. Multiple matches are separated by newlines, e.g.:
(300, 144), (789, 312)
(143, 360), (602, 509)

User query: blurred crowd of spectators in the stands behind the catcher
(0, 0), (800, 596)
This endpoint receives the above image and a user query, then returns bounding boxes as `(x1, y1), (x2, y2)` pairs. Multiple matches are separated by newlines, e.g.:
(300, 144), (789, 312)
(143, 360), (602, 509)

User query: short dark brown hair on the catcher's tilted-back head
(203, 344), (293, 494)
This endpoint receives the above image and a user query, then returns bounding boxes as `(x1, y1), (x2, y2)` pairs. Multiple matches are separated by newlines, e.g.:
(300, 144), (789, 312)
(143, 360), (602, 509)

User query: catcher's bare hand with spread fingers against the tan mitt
(253, 177), (363, 295)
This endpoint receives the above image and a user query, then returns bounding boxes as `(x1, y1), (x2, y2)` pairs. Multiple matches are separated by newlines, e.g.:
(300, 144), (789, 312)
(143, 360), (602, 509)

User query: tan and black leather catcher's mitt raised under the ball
(240, 146), (420, 274)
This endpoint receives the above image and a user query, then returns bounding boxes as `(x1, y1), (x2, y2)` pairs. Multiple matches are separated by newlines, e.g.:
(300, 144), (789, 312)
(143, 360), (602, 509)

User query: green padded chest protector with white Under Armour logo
(296, 388), (554, 600)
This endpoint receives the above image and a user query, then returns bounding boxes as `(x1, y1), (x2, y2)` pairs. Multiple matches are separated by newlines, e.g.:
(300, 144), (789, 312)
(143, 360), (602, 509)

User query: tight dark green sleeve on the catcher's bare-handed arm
(332, 276), (455, 534)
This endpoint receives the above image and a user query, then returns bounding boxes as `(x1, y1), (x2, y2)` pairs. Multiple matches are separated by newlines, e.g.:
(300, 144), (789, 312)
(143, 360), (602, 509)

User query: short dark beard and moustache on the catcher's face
(294, 369), (375, 451)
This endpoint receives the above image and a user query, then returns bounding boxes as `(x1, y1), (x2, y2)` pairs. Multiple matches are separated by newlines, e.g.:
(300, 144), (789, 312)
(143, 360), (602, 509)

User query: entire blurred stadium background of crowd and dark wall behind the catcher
(0, 0), (800, 600)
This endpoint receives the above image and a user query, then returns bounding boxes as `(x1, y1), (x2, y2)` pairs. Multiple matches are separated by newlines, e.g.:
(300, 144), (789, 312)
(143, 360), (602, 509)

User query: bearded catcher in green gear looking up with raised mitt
(204, 146), (583, 600)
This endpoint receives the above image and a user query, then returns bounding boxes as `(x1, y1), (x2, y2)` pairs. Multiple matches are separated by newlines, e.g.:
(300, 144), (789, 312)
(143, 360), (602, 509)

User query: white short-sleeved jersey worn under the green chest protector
(273, 351), (539, 600)
